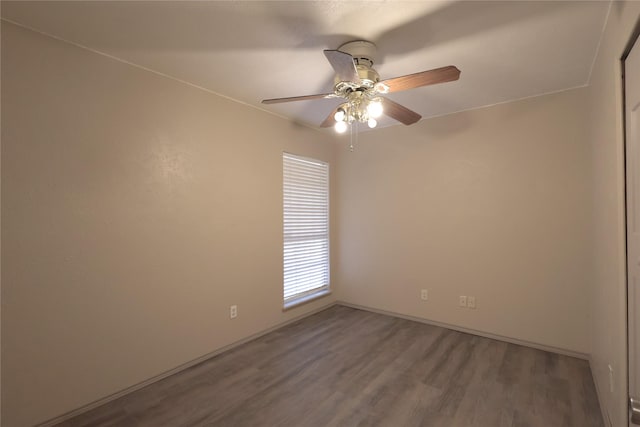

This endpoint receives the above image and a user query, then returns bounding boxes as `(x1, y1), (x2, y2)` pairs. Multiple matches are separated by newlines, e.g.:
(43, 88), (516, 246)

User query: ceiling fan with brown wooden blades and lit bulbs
(262, 40), (460, 133)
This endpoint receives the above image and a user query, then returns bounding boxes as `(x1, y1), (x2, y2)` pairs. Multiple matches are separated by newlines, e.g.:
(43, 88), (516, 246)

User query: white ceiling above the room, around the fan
(2, 0), (610, 130)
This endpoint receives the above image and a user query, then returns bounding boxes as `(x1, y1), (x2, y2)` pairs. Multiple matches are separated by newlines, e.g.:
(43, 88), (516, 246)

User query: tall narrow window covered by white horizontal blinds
(282, 153), (329, 308)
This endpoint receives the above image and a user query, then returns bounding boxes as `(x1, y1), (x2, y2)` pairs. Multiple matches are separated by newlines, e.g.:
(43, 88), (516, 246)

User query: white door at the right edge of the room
(625, 34), (640, 425)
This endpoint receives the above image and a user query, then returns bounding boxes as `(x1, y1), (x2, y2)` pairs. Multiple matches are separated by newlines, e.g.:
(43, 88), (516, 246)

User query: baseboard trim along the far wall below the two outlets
(336, 301), (589, 360)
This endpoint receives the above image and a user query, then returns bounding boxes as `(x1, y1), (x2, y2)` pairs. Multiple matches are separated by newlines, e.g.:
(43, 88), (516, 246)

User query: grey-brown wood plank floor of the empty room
(60, 306), (603, 427)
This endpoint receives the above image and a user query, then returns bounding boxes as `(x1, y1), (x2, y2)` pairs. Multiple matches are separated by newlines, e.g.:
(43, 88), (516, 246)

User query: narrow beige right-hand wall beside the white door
(587, 2), (640, 427)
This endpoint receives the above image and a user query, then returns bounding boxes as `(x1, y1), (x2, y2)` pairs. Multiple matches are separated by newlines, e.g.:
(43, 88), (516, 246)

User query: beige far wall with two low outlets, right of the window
(337, 87), (591, 353)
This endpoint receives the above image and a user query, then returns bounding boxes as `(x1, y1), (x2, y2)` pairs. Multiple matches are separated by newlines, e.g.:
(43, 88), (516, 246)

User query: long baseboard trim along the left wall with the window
(37, 301), (337, 427)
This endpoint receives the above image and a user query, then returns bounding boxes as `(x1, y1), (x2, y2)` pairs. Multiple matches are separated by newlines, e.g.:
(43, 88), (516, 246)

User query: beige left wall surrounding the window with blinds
(2, 23), (333, 426)
